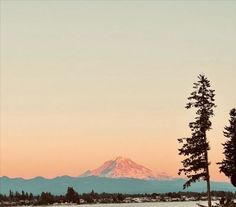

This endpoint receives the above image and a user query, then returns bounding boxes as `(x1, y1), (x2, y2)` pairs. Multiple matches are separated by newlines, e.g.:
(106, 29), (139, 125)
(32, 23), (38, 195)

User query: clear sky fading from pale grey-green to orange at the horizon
(0, 0), (236, 181)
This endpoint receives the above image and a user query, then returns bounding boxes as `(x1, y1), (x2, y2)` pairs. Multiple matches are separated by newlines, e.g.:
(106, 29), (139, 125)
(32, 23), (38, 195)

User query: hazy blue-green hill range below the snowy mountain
(0, 176), (236, 195)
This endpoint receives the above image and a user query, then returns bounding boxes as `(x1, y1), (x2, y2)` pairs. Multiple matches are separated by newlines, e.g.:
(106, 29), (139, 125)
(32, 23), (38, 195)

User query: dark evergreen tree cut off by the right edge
(217, 108), (236, 186)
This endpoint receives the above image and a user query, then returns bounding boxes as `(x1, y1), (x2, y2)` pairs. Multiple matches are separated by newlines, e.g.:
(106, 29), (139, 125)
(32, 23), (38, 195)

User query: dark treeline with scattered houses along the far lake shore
(0, 187), (236, 206)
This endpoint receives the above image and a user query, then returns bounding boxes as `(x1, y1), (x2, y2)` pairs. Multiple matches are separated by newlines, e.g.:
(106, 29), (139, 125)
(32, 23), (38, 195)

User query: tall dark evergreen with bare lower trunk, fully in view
(178, 75), (216, 207)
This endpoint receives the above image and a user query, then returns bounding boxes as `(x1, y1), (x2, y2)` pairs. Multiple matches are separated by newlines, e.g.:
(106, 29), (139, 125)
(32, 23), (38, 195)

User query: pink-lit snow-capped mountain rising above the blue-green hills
(81, 157), (169, 180)
